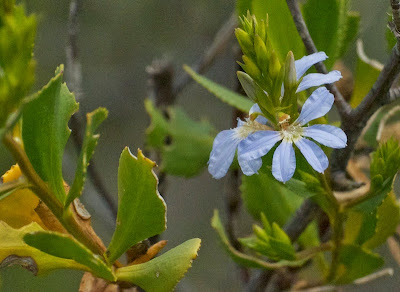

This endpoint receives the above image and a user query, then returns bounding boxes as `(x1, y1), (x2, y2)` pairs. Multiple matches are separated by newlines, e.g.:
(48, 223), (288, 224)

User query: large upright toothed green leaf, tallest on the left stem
(22, 65), (78, 202)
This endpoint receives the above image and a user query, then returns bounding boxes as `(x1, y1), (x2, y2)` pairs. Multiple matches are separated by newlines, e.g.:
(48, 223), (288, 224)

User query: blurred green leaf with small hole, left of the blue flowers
(145, 100), (215, 177)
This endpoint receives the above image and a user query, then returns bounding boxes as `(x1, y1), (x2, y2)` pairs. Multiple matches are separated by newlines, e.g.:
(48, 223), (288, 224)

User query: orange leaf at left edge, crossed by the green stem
(0, 165), (44, 228)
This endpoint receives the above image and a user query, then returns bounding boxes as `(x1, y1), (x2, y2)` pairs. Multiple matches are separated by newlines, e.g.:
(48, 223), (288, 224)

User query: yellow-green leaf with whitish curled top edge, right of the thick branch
(350, 40), (383, 107)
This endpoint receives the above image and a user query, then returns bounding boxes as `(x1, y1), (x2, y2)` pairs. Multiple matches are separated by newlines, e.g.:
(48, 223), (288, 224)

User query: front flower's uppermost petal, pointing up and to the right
(297, 87), (335, 125)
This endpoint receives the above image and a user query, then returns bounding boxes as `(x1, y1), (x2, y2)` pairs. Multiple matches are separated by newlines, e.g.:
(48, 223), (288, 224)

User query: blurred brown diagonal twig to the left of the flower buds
(173, 13), (238, 96)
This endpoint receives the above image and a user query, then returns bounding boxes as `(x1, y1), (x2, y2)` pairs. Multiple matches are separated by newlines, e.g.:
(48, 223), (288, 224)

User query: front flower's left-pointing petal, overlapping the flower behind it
(238, 131), (282, 160)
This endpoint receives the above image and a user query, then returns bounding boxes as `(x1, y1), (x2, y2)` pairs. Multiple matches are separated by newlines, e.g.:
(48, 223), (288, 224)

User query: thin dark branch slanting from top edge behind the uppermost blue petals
(286, 0), (352, 120)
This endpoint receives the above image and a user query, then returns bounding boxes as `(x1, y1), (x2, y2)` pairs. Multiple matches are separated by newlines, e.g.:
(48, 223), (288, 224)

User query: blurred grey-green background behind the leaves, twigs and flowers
(0, 0), (400, 292)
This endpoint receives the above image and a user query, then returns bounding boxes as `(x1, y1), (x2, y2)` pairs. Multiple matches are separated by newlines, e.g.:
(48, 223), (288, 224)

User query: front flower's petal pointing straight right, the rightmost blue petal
(303, 125), (347, 148)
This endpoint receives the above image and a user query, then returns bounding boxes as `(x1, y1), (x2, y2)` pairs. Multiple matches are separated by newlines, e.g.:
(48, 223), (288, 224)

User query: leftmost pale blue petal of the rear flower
(208, 130), (240, 179)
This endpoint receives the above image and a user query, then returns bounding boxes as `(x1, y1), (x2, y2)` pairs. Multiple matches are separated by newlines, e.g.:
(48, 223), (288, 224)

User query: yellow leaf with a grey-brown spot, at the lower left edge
(0, 221), (89, 275)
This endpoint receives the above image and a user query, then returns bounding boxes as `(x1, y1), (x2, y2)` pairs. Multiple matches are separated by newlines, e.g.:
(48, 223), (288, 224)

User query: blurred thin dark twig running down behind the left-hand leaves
(66, 0), (117, 218)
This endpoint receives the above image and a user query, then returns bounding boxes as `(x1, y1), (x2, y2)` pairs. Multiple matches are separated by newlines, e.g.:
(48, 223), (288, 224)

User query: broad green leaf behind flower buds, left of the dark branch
(251, 0), (305, 62)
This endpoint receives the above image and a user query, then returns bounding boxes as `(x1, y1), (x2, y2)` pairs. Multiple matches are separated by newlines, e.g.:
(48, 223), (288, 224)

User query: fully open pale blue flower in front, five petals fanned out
(238, 87), (347, 182)
